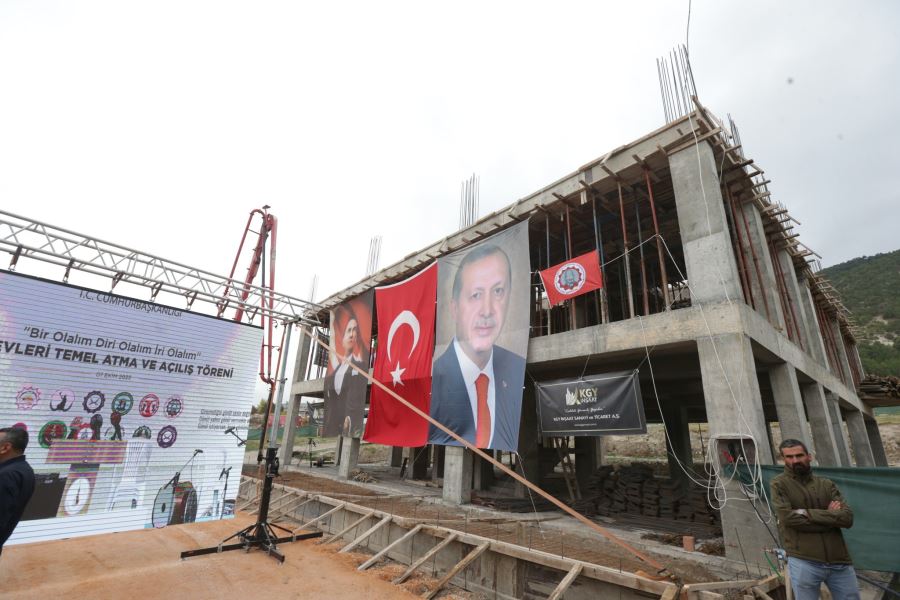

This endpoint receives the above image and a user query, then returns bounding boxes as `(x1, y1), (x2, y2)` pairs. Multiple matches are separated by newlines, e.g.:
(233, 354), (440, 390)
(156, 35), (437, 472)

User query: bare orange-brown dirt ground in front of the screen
(0, 513), (442, 600)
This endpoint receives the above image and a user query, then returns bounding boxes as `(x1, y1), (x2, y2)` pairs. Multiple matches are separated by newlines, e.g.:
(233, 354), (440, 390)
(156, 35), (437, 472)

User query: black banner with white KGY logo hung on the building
(537, 371), (647, 436)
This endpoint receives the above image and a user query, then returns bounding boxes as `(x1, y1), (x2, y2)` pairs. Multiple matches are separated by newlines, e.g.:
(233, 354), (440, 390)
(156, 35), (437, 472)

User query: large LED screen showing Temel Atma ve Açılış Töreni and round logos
(0, 271), (262, 543)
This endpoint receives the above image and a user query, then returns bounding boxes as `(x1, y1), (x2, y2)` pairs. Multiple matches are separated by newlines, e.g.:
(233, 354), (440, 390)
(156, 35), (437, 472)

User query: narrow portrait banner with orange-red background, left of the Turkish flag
(325, 290), (372, 437)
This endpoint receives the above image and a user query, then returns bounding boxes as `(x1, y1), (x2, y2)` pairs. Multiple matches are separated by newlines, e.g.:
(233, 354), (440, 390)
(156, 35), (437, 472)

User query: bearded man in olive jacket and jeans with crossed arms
(772, 439), (859, 600)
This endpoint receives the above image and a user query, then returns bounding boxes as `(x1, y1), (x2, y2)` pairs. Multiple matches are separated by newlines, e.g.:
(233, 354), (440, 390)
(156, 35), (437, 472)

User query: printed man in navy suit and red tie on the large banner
(428, 244), (525, 451)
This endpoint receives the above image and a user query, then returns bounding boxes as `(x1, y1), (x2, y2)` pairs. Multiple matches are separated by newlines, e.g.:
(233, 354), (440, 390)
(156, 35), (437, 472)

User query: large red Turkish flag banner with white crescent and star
(363, 263), (437, 447)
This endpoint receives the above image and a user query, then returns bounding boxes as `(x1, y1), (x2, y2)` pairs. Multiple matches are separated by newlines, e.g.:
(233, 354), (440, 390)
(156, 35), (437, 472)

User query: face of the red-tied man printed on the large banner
(451, 252), (509, 368)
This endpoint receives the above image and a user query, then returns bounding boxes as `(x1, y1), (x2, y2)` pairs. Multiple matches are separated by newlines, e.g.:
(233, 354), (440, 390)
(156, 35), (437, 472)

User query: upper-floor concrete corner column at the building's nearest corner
(669, 142), (743, 303)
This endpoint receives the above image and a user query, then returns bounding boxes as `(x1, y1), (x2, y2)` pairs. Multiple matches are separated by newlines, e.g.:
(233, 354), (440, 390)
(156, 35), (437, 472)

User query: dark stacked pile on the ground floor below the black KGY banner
(582, 465), (719, 526)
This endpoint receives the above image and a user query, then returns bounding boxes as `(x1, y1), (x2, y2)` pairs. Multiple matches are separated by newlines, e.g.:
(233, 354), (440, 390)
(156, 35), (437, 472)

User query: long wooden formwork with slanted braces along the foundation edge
(240, 478), (679, 600)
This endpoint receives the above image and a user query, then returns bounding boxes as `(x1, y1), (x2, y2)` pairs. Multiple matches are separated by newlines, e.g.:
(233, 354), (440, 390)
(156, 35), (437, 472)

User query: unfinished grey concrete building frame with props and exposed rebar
(282, 98), (887, 557)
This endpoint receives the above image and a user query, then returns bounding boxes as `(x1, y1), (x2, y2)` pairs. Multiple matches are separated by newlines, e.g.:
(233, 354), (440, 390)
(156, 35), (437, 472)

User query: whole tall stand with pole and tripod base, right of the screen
(181, 323), (322, 563)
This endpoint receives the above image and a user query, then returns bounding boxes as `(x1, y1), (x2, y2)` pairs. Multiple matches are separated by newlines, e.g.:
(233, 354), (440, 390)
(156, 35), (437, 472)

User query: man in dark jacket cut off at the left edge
(0, 427), (34, 552)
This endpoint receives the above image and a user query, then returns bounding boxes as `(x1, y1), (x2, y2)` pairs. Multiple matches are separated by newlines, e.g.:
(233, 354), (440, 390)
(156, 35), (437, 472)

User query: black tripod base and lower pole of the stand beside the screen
(181, 448), (322, 562)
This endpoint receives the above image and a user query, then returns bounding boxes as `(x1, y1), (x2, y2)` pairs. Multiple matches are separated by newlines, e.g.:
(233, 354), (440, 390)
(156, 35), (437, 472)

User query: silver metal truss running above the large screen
(0, 210), (322, 326)
